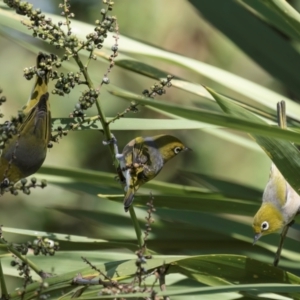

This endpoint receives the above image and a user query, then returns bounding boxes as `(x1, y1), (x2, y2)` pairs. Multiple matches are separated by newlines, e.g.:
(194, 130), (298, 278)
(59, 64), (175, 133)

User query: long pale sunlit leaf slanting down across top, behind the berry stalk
(0, 7), (300, 121)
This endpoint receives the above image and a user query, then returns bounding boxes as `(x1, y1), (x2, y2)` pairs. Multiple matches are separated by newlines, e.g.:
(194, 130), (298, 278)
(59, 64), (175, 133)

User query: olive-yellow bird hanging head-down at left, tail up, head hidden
(0, 53), (51, 187)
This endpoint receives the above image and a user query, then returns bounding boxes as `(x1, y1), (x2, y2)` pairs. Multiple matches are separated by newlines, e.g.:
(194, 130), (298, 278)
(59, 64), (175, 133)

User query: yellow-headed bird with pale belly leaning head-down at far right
(253, 101), (300, 265)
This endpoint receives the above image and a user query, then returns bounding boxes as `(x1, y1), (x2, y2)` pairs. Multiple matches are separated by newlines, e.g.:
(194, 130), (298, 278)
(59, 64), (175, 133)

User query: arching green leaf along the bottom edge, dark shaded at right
(5, 255), (300, 299)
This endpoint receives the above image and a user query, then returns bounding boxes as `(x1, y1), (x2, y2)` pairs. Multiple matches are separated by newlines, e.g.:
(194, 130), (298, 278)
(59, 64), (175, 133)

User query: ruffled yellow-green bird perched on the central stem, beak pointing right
(117, 134), (189, 211)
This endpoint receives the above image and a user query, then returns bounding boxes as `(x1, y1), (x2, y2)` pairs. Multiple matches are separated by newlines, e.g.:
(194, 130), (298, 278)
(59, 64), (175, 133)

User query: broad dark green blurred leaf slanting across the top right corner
(190, 0), (300, 95)
